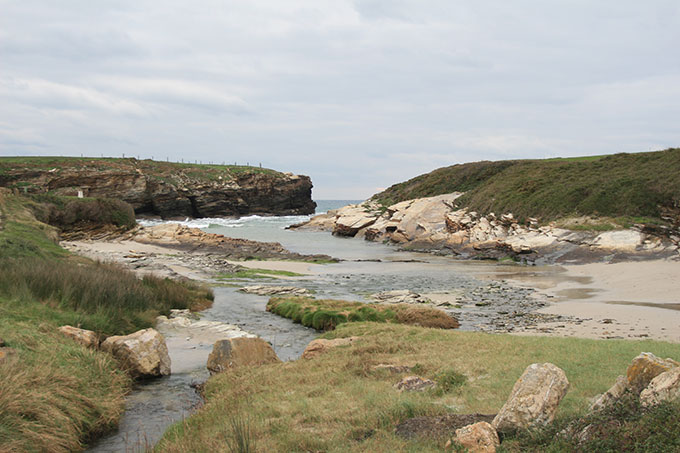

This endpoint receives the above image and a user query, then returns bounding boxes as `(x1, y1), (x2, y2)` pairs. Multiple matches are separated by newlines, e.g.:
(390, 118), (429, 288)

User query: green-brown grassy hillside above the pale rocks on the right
(373, 148), (680, 222)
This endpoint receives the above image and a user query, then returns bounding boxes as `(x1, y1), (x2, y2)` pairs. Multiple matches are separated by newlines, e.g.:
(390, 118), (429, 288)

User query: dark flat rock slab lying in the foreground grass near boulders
(394, 414), (496, 439)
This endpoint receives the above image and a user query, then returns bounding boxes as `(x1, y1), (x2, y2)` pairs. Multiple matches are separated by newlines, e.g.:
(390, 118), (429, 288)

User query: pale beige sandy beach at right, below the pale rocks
(504, 260), (680, 342)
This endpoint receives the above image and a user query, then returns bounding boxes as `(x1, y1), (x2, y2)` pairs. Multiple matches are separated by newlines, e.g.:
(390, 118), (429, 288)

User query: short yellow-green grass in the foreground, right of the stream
(156, 322), (680, 452)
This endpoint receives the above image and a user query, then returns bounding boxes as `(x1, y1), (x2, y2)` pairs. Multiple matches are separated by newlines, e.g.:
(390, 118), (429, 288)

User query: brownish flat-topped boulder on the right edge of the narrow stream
(207, 337), (281, 373)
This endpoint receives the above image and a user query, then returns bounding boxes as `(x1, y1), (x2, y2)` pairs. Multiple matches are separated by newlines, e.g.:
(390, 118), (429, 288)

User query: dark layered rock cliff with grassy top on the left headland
(0, 158), (316, 218)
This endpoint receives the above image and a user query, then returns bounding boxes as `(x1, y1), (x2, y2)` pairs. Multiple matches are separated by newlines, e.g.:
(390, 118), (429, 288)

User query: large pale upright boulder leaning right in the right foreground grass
(493, 363), (569, 432)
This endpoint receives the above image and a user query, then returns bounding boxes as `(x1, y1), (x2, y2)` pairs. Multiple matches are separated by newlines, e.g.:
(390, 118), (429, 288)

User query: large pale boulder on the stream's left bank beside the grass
(101, 329), (170, 379)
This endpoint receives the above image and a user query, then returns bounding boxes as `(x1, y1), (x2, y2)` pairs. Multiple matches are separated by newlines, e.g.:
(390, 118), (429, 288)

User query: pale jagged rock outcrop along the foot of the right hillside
(291, 192), (680, 262)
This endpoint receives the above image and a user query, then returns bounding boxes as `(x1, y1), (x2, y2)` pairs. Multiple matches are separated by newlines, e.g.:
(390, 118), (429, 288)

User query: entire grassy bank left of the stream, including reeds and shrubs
(0, 189), (212, 452)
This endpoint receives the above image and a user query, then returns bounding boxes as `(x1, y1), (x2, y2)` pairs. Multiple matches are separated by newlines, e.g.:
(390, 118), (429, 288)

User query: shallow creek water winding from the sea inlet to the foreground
(88, 200), (531, 452)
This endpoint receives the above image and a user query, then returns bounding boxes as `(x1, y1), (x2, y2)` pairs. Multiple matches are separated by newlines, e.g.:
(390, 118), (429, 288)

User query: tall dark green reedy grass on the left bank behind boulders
(0, 259), (213, 335)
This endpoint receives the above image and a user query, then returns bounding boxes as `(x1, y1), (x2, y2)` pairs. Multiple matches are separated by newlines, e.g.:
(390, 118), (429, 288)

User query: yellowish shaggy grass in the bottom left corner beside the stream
(0, 308), (129, 452)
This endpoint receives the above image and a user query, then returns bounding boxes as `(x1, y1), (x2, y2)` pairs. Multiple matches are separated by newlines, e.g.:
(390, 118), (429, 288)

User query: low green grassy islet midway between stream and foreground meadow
(267, 297), (457, 330)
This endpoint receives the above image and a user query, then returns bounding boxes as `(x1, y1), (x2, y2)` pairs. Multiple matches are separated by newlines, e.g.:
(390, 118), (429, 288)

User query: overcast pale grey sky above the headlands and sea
(0, 0), (680, 199)
